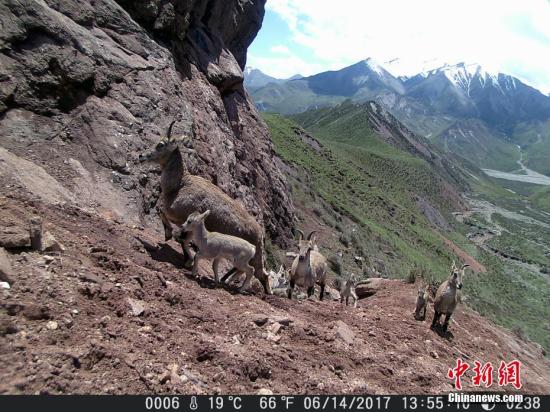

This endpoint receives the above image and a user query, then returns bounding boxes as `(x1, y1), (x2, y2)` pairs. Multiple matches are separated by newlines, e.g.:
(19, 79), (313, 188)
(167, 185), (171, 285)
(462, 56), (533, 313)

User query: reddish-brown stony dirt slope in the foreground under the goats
(0, 194), (550, 394)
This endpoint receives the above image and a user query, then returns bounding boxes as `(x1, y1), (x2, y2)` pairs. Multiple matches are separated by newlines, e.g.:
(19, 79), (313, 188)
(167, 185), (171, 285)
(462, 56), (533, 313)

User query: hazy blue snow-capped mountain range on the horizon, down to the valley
(245, 58), (550, 173)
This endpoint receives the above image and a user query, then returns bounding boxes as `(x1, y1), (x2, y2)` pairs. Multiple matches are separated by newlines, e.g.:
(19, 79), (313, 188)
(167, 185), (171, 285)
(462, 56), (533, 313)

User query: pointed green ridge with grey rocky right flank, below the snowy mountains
(292, 101), (467, 205)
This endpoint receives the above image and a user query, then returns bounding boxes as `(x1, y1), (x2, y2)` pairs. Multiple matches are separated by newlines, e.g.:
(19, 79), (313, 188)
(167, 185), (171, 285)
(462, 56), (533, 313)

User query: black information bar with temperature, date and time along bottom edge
(0, 394), (550, 412)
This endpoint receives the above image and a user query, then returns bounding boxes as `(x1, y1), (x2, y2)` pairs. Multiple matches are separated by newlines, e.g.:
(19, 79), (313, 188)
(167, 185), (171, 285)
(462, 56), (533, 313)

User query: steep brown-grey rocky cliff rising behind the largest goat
(0, 0), (293, 244)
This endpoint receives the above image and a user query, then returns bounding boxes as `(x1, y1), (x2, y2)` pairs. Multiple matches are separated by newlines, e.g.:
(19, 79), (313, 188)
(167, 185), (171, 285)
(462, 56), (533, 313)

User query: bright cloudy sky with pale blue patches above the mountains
(247, 0), (550, 94)
